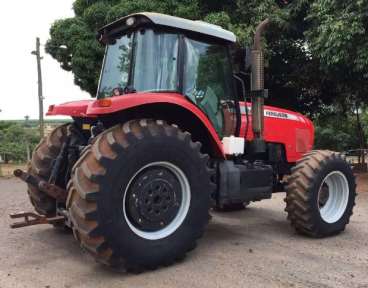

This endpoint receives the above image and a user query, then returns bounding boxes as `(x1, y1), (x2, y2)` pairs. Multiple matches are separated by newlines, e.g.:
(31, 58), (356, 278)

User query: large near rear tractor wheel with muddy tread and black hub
(67, 119), (214, 272)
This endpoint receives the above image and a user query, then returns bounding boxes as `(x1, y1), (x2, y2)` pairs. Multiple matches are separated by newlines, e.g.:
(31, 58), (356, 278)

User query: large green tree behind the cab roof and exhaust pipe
(46, 0), (335, 116)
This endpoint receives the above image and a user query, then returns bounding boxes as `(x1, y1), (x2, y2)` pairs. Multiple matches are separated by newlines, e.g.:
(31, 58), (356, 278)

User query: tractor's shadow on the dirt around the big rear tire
(28, 202), (293, 284)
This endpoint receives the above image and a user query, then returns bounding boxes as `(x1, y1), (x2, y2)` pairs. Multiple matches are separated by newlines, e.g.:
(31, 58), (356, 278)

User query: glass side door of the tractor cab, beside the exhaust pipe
(183, 37), (237, 138)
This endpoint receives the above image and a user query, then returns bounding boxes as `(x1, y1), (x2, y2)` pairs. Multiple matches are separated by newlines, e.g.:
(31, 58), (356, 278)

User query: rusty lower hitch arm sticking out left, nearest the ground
(9, 212), (66, 229)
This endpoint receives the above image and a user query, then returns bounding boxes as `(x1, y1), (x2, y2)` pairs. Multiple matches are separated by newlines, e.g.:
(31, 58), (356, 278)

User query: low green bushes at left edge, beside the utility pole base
(0, 121), (40, 162)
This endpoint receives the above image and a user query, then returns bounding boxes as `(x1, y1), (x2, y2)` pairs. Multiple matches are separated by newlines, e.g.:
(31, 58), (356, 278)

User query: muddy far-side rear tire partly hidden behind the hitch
(27, 124), (69, 217)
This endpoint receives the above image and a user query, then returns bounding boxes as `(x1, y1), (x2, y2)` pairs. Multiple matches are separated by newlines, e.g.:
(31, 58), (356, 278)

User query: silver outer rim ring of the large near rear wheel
(123, 162), (191, 240)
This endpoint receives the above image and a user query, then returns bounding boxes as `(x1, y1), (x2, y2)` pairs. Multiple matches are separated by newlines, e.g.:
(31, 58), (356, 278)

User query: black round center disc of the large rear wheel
(125, 166), (182, 232)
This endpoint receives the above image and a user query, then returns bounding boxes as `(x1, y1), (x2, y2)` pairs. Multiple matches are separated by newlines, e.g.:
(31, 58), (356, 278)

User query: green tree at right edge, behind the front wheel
(305, 0), (368, 162)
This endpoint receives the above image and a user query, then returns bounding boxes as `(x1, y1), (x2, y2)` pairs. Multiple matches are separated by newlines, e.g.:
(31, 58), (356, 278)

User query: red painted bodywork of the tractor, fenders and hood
(47, 93), (314, 162)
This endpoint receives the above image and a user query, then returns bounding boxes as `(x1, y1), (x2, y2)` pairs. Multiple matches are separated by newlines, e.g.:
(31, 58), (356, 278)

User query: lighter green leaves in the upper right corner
(306, 0), (368, 76)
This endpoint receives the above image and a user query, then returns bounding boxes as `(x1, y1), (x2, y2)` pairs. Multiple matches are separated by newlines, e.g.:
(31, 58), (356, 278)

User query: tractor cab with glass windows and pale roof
(97, 13), (236, 136)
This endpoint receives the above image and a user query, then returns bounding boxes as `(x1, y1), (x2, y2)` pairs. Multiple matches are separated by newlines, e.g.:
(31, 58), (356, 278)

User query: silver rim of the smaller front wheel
(317, 171), (349, 223)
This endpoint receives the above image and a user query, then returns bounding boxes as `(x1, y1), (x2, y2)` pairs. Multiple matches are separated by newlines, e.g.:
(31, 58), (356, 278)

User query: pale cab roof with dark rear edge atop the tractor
(99, 12), (236, 42)
